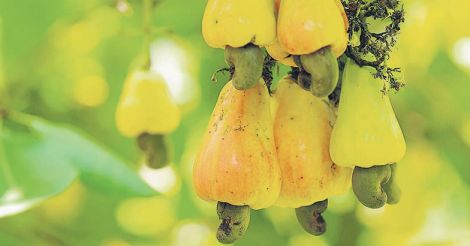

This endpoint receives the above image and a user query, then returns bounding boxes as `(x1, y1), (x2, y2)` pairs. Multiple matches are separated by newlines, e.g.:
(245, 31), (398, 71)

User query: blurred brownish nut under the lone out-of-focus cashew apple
(137, 133), (168, 169)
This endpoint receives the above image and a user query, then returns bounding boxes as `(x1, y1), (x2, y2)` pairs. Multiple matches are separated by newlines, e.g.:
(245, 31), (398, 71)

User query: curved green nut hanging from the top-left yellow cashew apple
(225, 44), (264, 90)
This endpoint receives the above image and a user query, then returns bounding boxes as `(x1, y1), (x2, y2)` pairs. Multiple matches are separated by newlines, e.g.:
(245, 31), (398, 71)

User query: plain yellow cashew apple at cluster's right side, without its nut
(330, 59), (406, 167)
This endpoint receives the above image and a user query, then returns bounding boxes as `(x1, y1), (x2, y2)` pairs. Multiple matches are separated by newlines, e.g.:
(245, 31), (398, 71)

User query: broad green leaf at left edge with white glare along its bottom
(0, 118), (77, 217)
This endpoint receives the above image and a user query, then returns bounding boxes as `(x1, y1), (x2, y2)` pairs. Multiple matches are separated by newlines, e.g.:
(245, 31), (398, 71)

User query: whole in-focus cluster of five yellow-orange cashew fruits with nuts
(193, 0), (405, 243)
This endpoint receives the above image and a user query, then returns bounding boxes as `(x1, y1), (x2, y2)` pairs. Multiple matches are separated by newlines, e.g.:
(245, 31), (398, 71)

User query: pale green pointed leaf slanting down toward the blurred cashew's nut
(31, 115), (155, 196)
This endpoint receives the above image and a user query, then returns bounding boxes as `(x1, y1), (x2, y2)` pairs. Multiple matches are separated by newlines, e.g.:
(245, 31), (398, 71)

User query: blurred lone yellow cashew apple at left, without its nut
(116, 70), (181, 137)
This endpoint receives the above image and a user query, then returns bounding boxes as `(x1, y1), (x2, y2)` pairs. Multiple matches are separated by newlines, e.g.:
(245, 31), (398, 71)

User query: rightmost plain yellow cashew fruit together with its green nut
(330, 59), (406, 208)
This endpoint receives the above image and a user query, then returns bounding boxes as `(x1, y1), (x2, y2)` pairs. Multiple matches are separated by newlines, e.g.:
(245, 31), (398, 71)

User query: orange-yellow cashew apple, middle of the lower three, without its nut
(274, 77), (352, 208)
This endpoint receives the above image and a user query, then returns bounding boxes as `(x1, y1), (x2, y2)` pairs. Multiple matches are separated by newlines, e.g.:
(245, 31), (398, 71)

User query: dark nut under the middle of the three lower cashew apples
(295, 200), (328, 236)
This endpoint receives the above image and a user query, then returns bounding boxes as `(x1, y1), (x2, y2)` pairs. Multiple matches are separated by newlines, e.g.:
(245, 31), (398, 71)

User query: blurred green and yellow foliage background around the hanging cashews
(0, 0), (470, 246)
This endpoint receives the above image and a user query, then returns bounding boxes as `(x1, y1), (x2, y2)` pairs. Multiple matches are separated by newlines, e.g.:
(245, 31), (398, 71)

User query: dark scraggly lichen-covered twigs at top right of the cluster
(341, 0), (405, 91)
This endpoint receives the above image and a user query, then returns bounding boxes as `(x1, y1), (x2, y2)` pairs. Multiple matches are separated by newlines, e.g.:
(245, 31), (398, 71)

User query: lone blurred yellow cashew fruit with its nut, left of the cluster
(116, 70), (181, 169)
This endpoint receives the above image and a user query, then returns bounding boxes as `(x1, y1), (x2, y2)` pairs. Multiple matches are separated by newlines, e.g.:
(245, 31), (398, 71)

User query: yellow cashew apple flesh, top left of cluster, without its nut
(202, 0), (276, 48)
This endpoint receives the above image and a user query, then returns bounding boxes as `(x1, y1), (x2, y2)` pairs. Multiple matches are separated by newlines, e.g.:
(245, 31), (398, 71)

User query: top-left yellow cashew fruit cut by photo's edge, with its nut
(202, 0), (276, 90)
